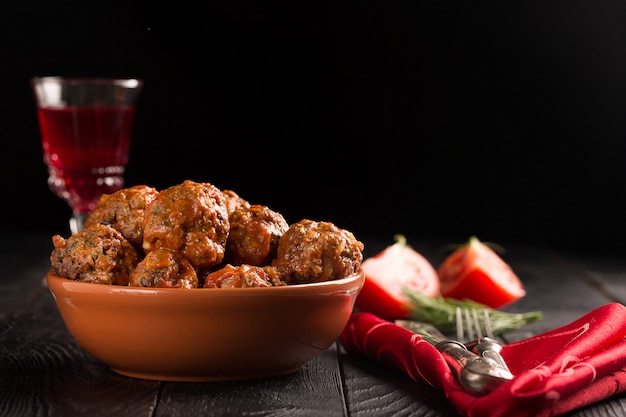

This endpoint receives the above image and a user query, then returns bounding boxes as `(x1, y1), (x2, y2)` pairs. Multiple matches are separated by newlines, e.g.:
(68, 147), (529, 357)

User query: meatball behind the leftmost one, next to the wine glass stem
(85, 185), (159, 251)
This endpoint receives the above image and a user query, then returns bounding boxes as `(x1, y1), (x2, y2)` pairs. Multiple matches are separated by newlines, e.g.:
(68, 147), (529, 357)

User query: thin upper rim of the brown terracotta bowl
(46, 269), (365, 296)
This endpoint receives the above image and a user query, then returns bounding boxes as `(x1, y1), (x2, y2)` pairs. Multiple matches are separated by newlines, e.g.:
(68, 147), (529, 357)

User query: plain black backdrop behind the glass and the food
(0, 0), (626, 252)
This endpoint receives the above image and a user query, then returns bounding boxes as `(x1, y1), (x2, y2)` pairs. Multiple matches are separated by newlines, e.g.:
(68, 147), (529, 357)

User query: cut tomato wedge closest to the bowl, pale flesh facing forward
(355, 235), (441, 320)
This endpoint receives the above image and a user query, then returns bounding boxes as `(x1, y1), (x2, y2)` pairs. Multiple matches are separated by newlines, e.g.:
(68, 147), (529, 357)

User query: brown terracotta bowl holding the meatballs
(46, 272), (364, 381)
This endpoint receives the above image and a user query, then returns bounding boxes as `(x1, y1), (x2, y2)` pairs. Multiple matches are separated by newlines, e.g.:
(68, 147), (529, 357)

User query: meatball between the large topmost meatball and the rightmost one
(224, 204), (289, 266)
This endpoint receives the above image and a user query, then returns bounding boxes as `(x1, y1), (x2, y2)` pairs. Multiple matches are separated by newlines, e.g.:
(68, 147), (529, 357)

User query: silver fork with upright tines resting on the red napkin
(455, 307), (511, 372)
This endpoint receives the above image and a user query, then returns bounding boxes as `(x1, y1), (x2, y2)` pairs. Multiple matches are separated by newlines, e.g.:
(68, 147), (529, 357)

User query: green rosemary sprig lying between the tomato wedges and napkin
(405, 290), (543, 336)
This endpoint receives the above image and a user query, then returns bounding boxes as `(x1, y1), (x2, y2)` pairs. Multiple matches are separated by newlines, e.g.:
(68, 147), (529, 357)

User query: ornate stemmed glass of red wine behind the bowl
(30, 77), (143, 234)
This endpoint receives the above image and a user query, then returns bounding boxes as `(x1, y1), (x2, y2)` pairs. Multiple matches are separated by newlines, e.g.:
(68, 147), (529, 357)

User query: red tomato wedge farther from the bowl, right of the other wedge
(437, 236), (526, 308)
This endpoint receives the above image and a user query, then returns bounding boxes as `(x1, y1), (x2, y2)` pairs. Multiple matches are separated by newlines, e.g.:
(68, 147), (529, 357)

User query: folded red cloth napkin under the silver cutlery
(340, 303), (626, 417)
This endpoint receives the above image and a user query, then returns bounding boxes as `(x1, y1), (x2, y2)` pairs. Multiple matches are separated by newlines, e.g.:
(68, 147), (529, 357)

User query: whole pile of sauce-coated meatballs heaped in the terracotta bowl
(50, 180), (364, 288)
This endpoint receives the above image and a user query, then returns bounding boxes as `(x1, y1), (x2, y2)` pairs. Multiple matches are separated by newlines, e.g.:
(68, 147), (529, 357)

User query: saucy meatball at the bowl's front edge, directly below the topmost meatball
(130, 248), (198, 288)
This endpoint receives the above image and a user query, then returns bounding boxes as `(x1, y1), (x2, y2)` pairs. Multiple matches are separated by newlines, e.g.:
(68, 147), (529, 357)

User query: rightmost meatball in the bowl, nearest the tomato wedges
(272, 219), (364, 284)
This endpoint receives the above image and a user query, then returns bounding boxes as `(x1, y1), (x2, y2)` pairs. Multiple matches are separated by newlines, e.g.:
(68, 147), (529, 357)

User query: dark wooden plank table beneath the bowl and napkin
(0, 234), (626, 417)
